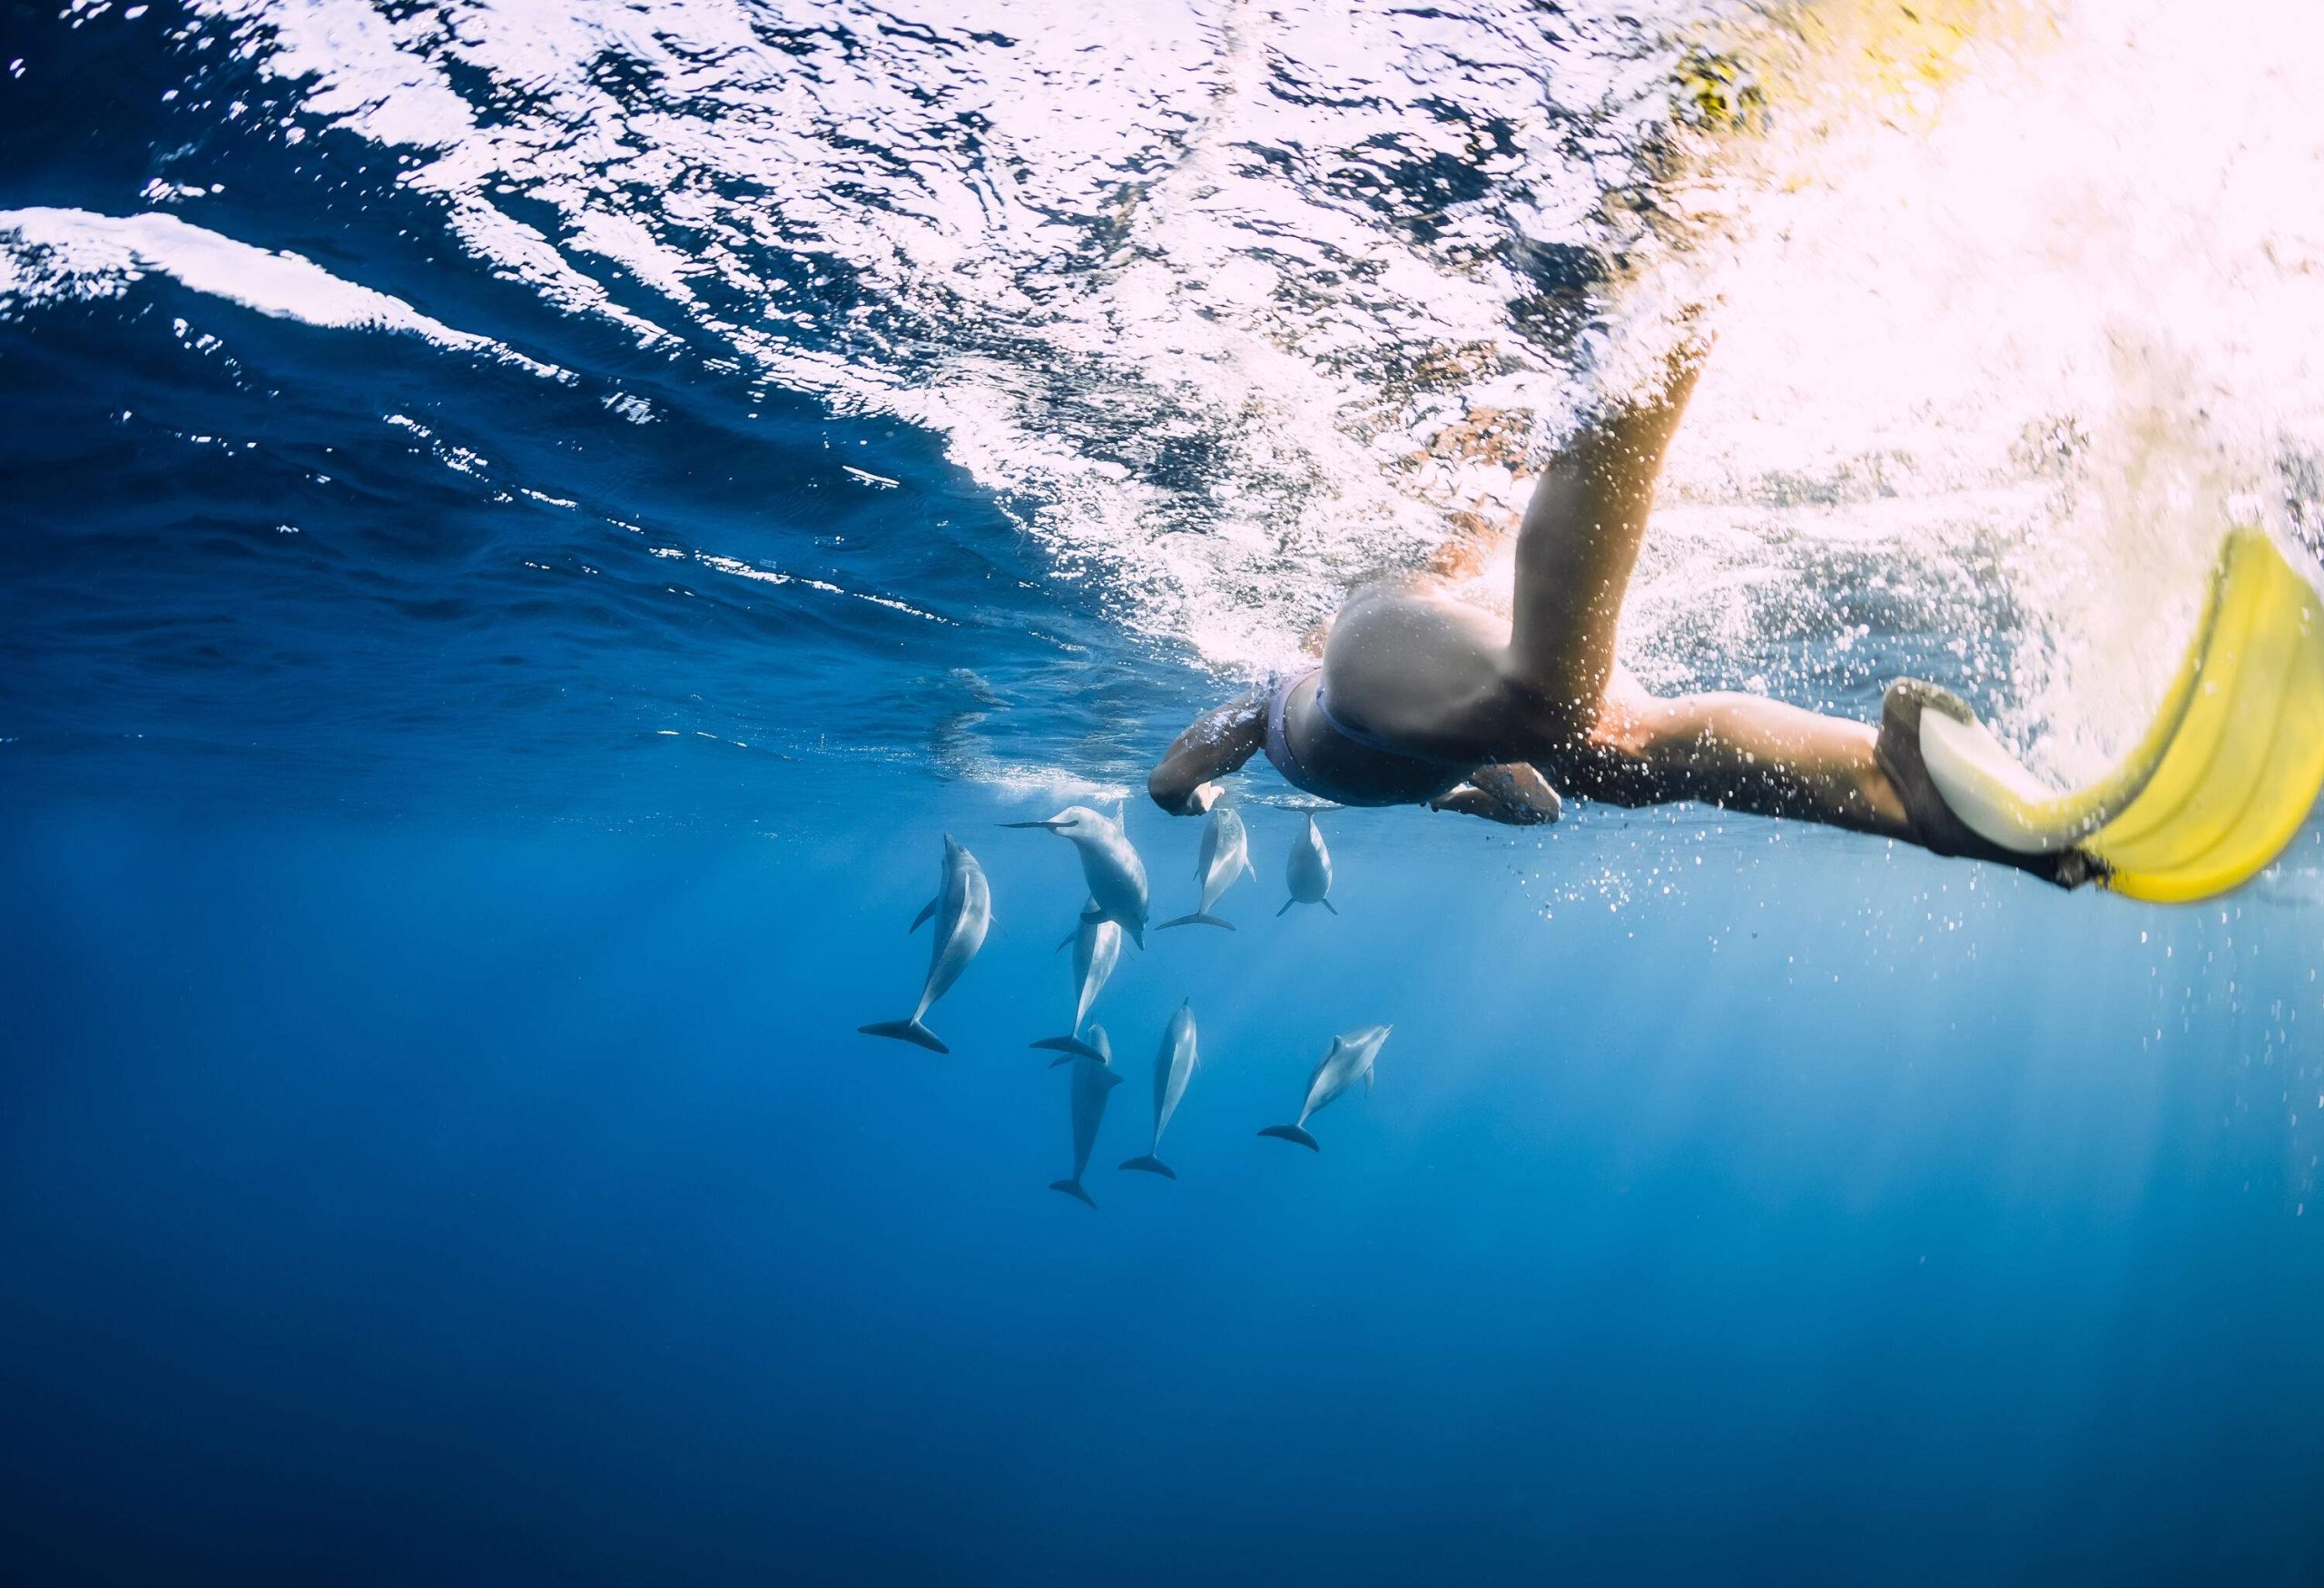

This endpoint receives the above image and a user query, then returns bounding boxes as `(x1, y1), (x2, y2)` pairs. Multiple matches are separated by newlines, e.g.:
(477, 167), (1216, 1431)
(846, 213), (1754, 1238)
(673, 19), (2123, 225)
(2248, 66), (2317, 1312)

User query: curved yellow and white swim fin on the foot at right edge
(1920, 530), (2324, 902)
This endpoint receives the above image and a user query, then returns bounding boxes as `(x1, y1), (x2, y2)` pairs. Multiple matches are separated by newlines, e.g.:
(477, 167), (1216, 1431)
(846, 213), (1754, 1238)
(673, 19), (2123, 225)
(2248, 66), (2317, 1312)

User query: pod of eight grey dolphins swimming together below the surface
(858, 804), (1390, 1209)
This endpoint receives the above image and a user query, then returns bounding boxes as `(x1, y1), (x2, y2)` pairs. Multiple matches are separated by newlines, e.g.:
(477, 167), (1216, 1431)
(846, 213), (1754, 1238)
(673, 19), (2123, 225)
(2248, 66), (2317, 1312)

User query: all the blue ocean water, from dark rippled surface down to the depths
(0, 5), (2324, 1585)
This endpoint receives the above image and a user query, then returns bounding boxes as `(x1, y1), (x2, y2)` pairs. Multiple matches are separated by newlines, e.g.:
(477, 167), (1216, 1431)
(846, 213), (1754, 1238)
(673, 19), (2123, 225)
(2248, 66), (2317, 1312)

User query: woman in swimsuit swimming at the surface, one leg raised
(1148, 344), (2096, 886)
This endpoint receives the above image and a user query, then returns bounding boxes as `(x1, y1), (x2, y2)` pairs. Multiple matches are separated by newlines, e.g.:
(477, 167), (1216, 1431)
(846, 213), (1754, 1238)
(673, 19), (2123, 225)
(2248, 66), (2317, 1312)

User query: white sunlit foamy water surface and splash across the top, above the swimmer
(127, 0), (2324, 794)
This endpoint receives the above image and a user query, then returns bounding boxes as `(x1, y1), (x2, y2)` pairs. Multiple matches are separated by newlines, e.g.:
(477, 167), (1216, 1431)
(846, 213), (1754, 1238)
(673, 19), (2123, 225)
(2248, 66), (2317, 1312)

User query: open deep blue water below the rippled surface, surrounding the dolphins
(14, 814), (2324, 1583)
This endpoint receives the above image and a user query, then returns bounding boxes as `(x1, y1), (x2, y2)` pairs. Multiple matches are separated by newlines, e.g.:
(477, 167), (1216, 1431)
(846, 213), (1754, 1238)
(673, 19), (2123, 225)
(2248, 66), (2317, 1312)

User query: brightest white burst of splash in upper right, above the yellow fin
(1657, 0), (2324, 779)
